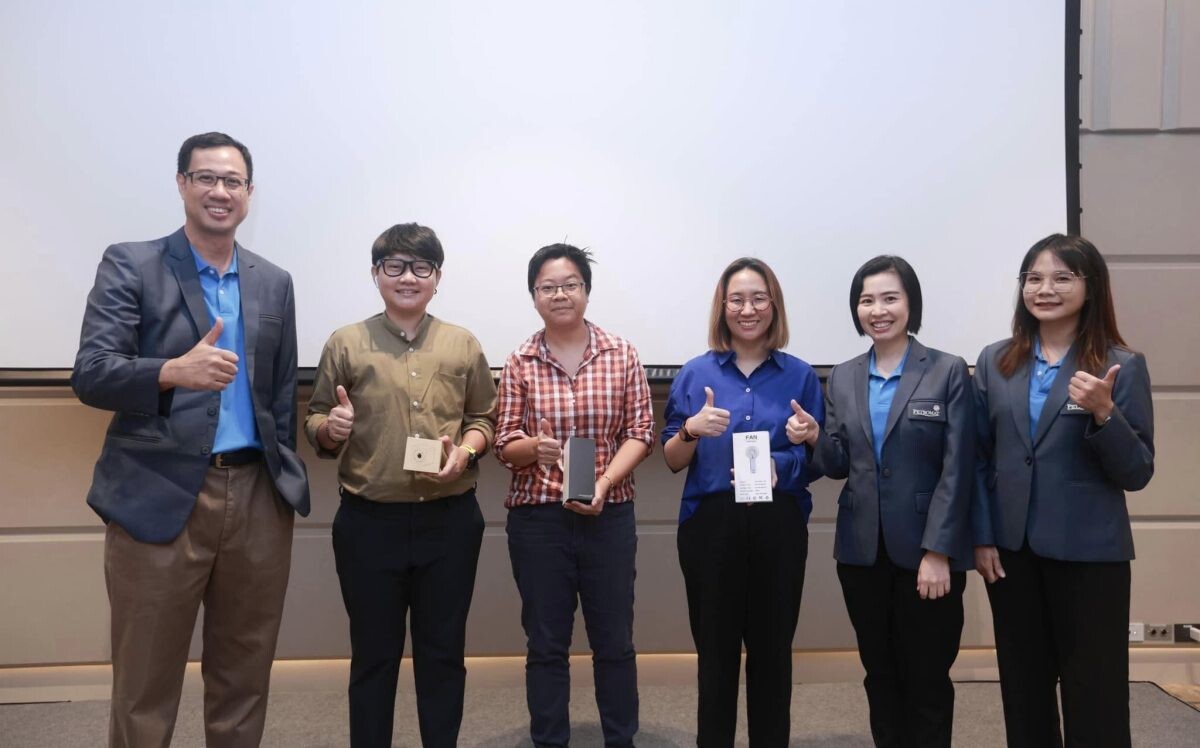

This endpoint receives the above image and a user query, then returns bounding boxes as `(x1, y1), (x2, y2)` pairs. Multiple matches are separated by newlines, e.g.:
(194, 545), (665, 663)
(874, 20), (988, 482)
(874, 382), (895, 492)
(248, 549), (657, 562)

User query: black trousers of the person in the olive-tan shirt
(334, 491), (484, 748)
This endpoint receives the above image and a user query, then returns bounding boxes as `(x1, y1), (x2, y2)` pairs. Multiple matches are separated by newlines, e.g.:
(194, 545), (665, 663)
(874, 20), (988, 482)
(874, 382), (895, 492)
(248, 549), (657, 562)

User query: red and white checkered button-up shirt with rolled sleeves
(494, 321), (654, 507)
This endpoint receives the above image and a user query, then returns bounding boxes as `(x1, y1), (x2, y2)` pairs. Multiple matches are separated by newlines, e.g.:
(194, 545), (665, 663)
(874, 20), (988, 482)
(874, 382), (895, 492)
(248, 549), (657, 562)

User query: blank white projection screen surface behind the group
(0, 0), (1067, 369)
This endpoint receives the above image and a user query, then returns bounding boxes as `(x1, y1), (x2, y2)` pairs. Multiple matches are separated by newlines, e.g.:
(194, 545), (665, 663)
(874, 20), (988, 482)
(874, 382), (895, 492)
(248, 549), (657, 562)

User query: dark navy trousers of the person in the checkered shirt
(508, 502), (637, 747)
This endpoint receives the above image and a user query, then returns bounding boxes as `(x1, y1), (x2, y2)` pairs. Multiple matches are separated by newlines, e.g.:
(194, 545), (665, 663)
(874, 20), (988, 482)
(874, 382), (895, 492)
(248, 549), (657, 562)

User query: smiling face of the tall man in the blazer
(175, 145), (254, 240)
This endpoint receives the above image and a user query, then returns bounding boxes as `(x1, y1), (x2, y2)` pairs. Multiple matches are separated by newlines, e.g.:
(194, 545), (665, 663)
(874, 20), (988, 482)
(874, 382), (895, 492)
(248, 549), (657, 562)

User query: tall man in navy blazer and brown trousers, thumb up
(71, 132), (308, 747)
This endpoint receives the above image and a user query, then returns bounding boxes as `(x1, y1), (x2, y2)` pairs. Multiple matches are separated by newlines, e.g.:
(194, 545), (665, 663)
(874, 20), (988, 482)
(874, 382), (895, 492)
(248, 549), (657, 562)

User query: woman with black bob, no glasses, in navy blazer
(787, 256), (974, 747)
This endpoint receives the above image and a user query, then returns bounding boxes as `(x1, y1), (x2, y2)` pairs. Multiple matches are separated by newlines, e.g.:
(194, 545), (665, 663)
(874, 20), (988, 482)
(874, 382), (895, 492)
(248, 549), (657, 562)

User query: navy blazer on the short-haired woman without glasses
(812, 339), (974, 572)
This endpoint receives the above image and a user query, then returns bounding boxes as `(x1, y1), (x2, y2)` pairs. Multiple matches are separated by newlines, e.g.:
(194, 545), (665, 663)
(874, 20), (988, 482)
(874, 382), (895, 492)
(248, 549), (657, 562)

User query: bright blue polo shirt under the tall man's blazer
(187, 244), (263, 453)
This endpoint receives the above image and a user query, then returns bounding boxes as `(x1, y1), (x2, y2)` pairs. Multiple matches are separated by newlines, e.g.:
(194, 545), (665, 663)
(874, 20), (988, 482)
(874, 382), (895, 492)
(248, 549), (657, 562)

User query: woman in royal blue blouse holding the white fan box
(662, 257), (823, 748)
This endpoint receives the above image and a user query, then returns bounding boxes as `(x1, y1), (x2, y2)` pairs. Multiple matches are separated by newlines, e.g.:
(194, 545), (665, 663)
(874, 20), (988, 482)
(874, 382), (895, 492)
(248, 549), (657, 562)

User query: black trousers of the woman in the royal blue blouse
(677, 492), (809, 748)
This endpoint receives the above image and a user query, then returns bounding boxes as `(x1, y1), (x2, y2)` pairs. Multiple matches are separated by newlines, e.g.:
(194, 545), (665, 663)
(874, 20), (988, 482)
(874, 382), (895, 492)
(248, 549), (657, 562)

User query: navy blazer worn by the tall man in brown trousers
(71, 229), (308, 543)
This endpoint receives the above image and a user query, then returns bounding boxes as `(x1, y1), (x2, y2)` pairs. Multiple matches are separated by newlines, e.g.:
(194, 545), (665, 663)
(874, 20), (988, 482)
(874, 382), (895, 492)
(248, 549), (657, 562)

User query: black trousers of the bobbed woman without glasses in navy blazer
(838, 538), (966, 748)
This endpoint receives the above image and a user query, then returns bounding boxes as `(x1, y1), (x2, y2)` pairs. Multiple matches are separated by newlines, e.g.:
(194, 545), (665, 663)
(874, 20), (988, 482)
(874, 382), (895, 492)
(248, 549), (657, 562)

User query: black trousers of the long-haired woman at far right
(988, 544), (1129, 748)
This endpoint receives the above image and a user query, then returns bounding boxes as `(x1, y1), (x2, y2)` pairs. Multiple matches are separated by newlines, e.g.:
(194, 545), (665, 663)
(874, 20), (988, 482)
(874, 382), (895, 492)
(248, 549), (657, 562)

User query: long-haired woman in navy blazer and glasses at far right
(971, 234), (1154, 747)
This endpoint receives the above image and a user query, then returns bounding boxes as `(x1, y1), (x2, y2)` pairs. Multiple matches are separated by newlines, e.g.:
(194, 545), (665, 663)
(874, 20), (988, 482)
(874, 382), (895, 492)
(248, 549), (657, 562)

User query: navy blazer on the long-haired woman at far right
(971, 340), (1154, 561)
